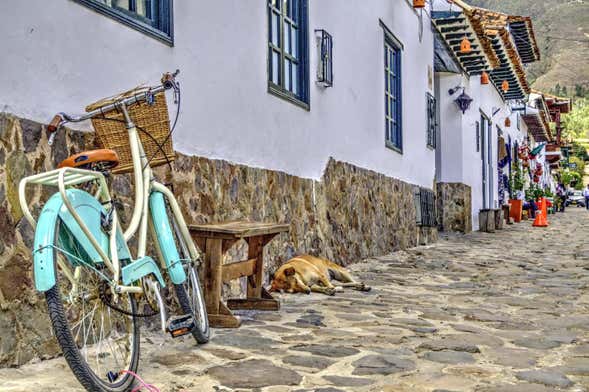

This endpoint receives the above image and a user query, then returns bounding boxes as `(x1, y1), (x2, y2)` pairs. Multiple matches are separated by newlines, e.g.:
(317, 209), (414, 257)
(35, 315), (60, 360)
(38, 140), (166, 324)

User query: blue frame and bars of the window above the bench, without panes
(266, 0), (311, 110)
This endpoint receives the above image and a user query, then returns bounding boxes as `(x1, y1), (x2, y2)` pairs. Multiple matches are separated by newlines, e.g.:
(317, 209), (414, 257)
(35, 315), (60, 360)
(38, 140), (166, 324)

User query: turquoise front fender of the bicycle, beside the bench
(149, 192), (186, 284)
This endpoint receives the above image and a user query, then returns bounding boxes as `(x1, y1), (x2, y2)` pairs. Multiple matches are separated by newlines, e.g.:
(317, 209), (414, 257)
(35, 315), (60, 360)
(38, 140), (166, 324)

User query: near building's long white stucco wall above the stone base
(0, 0), (435, 187)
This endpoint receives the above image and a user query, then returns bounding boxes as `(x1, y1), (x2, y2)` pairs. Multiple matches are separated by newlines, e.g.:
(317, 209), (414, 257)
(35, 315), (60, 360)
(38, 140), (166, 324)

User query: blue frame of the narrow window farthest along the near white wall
(380, 21), (404, 154)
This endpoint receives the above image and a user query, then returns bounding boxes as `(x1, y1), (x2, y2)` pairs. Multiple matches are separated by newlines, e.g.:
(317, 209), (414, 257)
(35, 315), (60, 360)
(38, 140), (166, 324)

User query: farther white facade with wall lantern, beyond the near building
(436, 73), (527, 230)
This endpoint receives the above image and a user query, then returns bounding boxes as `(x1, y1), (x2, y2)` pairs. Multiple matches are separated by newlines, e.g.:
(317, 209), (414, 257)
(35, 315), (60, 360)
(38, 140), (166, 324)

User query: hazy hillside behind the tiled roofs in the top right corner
(467, 0), (589, 96)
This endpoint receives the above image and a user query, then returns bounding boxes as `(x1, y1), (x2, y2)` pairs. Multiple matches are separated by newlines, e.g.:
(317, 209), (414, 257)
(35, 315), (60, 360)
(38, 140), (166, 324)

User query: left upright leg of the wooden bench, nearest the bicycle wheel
(205, 238), (223, 314)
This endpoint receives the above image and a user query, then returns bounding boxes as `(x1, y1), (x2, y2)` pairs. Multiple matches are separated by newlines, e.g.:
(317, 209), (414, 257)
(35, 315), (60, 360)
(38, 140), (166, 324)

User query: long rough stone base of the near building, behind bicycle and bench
(0, 114), (437, 366)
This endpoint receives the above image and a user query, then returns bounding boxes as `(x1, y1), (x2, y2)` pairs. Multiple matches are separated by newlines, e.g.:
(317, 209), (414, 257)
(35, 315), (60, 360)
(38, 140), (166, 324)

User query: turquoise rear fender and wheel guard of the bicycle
(33, 189), (131, 291)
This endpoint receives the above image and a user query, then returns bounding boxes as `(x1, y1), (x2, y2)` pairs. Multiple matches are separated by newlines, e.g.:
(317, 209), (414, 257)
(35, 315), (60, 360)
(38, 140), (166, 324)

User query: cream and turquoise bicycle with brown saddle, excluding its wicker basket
(19, 71), (209, 392)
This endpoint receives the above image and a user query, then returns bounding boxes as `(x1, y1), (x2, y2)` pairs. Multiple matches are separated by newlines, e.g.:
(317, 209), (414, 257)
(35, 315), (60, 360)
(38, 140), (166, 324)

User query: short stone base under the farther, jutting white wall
(436, 182), (472, 233)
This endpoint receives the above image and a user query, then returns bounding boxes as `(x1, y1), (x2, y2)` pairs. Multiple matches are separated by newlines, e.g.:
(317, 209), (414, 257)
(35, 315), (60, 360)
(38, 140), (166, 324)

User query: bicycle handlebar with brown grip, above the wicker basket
(47, 69), (180, 146)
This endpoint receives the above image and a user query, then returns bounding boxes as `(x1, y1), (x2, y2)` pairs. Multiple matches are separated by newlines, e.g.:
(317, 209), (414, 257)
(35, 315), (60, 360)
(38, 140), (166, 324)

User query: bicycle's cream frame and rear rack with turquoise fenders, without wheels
(19, 102), (198, 300)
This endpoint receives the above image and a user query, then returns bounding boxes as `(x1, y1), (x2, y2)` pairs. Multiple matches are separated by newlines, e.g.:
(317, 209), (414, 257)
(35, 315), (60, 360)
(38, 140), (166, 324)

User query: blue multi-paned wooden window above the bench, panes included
(268, 0), (309, 107)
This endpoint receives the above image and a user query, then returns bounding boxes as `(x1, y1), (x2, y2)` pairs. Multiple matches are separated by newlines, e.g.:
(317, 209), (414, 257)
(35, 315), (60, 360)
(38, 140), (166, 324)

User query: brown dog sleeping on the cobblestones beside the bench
(270, 255), (370, 295)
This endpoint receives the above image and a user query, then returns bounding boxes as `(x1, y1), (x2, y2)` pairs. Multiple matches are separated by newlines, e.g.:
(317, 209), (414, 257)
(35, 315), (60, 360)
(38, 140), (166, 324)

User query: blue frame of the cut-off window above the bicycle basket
(74, 0), (174, 46)
